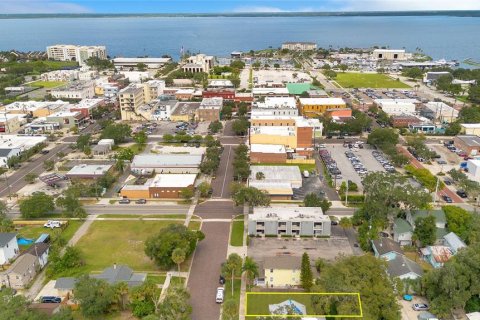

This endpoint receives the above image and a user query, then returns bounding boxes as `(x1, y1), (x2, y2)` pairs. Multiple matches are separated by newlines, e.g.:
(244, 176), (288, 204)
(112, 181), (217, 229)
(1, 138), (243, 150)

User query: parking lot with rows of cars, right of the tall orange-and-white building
(326, 144), (385, 192)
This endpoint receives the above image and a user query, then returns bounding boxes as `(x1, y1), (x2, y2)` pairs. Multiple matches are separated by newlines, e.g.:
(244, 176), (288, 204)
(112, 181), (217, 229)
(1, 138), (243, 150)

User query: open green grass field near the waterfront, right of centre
(335, 72), (410, 88)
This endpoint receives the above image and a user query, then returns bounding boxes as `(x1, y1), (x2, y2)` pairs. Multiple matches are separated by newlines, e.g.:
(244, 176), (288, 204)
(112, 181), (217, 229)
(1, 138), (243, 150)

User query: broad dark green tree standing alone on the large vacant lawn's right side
(145, 224), (205, 268)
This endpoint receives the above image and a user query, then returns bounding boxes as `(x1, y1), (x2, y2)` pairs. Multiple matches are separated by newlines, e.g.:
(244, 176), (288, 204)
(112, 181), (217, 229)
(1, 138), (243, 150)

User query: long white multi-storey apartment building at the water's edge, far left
(47, 44), (107, 65)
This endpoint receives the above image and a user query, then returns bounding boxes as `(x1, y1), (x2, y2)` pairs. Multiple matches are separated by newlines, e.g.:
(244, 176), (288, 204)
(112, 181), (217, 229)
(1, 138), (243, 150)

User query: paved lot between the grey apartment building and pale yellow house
(248, 238), (353, 261)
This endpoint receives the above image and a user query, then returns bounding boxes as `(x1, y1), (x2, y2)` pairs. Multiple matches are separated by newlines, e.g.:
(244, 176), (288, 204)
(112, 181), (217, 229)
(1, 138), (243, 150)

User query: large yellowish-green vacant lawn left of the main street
(77, 221), (182, 272)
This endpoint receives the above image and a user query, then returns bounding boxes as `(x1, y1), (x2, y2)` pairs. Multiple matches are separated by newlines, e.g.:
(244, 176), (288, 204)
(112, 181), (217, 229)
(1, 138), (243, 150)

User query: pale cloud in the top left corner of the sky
(0, 0), (91, 14)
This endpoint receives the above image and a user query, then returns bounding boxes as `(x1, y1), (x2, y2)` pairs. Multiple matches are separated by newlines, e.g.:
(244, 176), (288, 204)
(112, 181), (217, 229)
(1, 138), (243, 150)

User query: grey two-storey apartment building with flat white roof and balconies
(248, 206), (331, 237)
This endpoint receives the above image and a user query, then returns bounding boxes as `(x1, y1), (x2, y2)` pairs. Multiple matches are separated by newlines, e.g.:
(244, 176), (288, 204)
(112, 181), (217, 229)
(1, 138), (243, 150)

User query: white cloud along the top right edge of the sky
(333, 0), (480, 11)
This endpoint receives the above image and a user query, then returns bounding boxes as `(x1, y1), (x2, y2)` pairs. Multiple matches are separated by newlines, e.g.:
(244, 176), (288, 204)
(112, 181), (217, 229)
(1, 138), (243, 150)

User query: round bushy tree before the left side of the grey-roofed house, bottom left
(73, 276), (114, 319)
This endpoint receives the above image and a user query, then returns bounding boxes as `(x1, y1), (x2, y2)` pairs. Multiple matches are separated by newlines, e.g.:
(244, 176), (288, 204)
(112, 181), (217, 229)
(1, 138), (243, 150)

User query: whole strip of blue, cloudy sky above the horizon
(0, 0), (480, 14)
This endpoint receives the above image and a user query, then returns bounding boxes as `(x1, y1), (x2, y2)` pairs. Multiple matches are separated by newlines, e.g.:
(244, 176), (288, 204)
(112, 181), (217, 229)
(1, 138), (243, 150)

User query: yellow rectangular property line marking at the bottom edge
(245, 292), (363, 318)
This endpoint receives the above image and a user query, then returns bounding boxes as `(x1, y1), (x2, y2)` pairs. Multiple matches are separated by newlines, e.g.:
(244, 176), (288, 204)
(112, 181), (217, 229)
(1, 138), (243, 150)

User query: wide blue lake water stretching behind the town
(0, 16), (480, 61)
